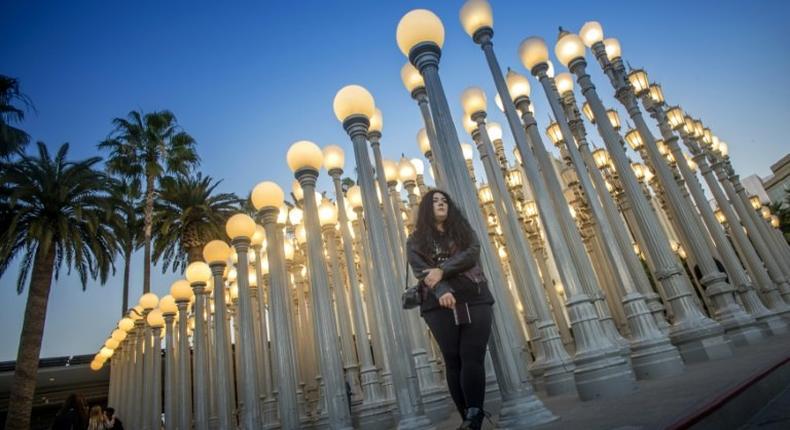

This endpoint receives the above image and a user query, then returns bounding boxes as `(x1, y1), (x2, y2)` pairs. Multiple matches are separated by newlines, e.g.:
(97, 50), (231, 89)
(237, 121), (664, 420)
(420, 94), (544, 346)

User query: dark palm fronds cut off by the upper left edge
(0, 75), (33, 159)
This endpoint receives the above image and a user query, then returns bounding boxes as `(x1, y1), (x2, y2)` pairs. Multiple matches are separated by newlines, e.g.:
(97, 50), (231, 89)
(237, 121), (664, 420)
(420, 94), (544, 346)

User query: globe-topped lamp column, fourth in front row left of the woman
(225, 213), (263, 429)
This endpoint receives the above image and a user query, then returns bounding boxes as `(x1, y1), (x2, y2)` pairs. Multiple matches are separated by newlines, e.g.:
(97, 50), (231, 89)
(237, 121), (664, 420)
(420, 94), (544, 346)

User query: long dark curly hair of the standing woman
(412, 189), (474, 255)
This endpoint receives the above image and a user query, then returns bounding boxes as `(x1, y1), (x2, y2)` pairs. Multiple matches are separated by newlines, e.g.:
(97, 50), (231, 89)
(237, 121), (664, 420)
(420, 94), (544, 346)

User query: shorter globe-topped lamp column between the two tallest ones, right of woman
(461, 87), (575, 395)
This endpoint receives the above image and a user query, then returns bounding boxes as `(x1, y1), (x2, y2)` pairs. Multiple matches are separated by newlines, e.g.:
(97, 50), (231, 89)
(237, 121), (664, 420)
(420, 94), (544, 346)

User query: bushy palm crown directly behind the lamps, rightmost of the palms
(153, 173), (241, 272)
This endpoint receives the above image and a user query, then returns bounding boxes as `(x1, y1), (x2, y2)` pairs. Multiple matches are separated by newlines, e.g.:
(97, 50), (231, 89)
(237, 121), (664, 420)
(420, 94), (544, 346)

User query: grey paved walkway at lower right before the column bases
(437, 335), (790, 430)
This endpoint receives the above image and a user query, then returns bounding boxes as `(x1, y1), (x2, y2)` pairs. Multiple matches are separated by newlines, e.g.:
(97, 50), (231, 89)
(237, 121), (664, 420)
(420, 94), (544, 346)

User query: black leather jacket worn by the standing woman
(406, 230), (493, 312)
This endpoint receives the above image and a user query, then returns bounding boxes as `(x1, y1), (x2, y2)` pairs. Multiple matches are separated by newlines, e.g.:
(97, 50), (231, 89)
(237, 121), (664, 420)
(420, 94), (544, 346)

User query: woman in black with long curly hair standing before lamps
(406, 190), (494, 429)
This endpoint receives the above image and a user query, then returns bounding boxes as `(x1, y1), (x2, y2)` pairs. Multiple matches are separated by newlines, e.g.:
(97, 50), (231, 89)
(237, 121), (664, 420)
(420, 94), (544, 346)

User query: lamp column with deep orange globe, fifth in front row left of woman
(203, 240), (236, 429)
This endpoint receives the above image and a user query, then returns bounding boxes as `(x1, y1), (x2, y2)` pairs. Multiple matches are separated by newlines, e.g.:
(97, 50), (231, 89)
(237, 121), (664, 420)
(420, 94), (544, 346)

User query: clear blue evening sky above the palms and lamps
(0, 1), (790, 360)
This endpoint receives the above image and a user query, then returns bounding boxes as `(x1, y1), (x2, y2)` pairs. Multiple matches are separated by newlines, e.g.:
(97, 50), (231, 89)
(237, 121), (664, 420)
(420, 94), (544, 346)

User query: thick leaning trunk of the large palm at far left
(5, 244), (55, 430)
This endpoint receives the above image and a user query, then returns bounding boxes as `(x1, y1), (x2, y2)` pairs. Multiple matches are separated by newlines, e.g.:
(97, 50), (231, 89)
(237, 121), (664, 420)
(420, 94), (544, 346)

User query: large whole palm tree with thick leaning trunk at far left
(0, 142), (116, 429)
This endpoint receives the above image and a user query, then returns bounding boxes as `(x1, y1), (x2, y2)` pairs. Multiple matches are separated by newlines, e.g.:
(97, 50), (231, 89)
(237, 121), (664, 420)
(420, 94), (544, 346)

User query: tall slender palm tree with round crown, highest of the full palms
(99, 110), (200, 293)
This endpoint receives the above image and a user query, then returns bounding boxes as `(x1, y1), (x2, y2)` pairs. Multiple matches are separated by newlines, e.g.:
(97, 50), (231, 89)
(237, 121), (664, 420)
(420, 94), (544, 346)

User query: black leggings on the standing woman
(422, 303), (491, 415)
